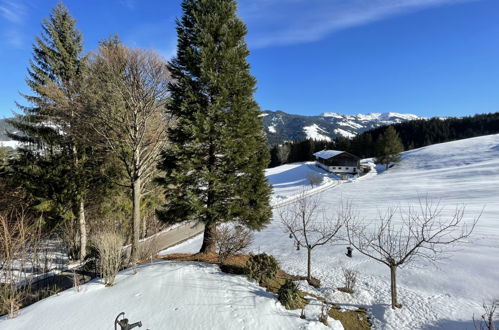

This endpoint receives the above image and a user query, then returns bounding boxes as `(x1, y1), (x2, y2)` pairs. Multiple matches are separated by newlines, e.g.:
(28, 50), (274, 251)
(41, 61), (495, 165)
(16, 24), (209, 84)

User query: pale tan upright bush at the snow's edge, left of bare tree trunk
(94, 231), (124, 286)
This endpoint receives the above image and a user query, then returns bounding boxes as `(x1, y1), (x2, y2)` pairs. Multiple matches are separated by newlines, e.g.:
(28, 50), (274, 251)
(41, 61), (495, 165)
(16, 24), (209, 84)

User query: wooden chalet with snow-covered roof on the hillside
(314, 150), (360, 174)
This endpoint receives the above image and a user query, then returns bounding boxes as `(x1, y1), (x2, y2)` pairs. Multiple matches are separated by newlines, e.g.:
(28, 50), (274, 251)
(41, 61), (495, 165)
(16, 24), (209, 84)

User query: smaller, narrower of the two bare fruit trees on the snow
(279, 192), (344, 283)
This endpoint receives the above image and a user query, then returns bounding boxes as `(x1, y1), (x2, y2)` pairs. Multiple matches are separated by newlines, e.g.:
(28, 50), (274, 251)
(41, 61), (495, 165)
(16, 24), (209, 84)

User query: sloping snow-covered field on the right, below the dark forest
(252, 135), (499, 330)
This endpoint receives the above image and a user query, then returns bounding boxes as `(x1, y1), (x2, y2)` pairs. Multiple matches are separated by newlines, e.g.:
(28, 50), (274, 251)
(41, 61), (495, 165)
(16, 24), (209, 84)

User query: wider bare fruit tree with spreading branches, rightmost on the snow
(341, 199), (480, 308)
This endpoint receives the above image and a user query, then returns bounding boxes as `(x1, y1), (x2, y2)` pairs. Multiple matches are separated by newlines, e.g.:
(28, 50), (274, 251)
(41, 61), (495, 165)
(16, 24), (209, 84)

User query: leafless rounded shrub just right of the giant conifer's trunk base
(215, 224), (253, 264)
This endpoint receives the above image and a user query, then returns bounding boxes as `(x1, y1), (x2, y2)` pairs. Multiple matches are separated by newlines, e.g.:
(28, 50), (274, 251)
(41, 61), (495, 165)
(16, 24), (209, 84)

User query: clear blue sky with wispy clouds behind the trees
(0, 0), (499, 118)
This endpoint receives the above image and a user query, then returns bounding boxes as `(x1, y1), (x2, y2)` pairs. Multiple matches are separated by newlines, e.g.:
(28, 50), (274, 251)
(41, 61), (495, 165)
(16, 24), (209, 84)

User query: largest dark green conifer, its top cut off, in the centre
(159, 0), (271, 253)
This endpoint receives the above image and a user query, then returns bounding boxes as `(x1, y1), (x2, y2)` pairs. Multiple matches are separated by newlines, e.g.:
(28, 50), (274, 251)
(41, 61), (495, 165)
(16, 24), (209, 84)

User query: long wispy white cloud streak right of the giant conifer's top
(239, 0), (476, 48)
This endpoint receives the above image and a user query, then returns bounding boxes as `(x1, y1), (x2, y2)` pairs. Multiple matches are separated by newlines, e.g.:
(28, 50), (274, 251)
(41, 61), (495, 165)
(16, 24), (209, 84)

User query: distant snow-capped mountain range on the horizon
(263, 110), (422, 144)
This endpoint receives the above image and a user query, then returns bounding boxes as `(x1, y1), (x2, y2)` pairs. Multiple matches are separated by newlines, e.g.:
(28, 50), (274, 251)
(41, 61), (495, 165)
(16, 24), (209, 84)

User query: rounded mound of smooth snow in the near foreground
(0, 261), (343, 330)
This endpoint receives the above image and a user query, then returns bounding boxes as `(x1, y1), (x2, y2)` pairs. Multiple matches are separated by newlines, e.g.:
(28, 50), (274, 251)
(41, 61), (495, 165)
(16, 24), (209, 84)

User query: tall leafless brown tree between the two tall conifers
(87, 39), (171, 263)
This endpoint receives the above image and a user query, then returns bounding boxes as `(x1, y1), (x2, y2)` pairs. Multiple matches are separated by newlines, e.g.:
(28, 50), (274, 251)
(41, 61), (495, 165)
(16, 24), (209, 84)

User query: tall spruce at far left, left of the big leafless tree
(10, 2), (89, 259)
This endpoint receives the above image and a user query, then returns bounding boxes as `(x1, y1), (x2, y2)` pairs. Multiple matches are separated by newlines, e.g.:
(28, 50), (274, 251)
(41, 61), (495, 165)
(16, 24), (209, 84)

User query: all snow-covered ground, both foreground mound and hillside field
(0, 135), (499, 330)
